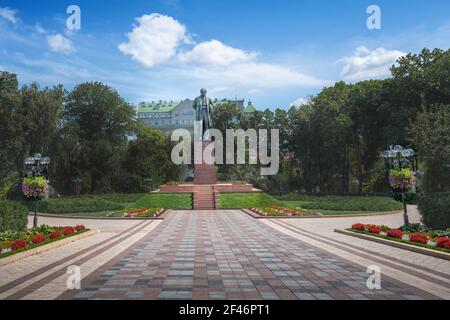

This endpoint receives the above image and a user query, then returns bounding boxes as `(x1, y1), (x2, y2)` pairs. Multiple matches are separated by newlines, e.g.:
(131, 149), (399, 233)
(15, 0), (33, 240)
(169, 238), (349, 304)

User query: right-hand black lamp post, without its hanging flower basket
(383, 145), (417, 225)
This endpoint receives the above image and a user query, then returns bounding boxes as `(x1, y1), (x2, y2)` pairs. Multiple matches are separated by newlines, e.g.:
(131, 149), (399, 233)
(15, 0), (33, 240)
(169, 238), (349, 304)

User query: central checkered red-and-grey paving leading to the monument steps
(57, 210), (436, 300)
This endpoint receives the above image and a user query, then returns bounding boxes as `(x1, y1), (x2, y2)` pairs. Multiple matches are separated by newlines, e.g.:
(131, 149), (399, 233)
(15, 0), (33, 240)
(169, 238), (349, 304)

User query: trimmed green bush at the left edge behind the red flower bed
(0, 201), (28, 231)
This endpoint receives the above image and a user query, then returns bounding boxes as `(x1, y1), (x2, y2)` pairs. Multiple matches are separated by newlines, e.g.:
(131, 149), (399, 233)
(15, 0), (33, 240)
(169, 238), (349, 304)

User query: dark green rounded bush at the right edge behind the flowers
(419, 192), (450, 230)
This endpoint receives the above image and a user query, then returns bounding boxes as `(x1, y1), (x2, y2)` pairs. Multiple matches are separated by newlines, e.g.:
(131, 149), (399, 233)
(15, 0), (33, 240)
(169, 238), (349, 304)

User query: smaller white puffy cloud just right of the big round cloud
(179, 40), (256, 66)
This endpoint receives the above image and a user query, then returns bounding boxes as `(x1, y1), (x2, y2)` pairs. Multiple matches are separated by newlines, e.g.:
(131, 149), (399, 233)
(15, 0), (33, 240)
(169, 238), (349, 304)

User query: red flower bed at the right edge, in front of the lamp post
(347, 223), (450, 253)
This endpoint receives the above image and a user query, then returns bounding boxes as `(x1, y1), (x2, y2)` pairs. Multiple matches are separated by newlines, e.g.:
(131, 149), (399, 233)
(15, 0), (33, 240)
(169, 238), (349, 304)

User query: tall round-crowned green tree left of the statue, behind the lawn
(63, 82), (135, 193)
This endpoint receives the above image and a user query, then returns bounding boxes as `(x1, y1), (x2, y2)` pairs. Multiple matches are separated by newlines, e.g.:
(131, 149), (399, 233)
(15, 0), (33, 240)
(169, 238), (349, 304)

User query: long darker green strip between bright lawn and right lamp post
(277, 194), (402, 214)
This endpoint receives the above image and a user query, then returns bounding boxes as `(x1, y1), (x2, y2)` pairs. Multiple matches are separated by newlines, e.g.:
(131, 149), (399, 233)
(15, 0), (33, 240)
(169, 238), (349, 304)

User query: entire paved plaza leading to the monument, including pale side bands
(0, 211), (450, 299)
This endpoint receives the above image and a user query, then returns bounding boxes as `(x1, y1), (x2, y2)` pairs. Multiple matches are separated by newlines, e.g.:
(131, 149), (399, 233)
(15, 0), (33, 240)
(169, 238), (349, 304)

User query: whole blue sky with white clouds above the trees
(0, 0), (450, 109)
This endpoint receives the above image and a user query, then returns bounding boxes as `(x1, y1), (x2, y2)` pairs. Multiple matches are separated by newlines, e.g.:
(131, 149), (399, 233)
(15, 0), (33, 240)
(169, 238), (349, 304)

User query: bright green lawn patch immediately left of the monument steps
(133, 193), (192, 210)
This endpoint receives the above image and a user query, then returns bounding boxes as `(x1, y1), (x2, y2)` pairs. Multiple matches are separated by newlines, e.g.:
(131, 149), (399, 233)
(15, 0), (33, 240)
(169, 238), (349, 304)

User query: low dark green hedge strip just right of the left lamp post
(44, 197), (124, 213)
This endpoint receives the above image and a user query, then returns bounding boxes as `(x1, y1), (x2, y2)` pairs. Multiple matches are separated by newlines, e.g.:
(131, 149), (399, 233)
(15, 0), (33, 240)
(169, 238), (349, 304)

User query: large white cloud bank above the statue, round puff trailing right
(119, 13), (324, 90)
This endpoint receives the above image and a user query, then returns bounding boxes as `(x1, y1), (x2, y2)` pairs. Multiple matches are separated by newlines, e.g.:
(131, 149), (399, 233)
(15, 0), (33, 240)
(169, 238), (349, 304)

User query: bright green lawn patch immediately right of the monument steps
(220, 192), (284, 209)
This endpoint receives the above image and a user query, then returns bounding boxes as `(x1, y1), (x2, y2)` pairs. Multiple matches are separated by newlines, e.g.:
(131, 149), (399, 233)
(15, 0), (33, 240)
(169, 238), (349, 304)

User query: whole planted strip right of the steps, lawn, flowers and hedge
(220, 193), (402, 217)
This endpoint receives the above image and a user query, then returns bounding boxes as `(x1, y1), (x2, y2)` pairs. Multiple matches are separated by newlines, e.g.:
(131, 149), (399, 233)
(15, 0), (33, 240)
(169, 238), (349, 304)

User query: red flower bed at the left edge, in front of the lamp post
(0, 225), (89, 258)
